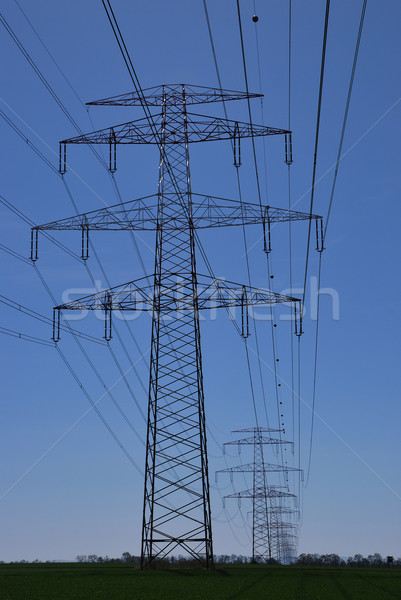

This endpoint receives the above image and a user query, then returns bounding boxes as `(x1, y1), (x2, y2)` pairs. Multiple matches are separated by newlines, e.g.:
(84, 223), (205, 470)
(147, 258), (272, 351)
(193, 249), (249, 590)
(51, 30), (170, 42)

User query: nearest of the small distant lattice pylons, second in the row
(216, 427), (299, 562)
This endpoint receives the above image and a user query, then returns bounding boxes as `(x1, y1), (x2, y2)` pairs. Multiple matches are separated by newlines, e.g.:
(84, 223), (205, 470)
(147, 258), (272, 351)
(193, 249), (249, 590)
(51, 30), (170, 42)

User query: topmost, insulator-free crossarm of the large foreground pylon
(87, 83), (263, 106)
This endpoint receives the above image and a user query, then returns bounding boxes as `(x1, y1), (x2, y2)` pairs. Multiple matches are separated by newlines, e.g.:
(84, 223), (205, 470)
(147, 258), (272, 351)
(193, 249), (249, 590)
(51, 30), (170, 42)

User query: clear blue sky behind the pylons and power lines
(0, 0), (401, 561)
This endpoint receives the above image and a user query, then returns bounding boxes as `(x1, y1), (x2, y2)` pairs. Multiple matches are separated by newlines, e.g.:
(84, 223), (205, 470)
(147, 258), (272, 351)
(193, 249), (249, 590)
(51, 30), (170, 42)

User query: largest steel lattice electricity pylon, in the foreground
(31, 85), (321, 567)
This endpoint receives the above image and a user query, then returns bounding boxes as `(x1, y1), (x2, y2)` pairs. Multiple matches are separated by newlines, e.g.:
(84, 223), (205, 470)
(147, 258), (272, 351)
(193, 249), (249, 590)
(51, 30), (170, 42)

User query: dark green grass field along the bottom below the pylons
(0, 563), (401, 600)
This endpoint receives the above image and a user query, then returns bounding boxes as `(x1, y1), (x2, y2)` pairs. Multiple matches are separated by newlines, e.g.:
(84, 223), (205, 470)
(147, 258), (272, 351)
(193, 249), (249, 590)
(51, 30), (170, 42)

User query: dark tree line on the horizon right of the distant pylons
(295, 552), (401, 569)
